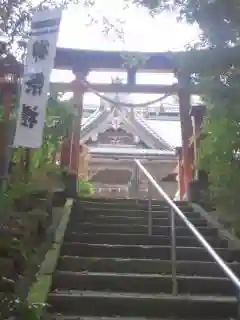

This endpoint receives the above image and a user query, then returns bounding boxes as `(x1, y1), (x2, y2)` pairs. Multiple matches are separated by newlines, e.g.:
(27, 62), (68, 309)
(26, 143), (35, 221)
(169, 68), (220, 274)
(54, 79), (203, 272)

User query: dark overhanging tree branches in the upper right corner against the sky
(133, 0), (240, 47)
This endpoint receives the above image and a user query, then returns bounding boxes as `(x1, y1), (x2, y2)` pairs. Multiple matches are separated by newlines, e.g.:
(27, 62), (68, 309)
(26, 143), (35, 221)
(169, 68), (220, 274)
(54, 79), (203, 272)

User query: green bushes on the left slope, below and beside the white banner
(0, 99), (73, 320)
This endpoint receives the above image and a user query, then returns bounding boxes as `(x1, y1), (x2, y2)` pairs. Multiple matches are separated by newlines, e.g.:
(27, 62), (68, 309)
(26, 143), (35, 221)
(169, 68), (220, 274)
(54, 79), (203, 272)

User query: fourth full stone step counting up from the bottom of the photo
(61, 242), (240, 262)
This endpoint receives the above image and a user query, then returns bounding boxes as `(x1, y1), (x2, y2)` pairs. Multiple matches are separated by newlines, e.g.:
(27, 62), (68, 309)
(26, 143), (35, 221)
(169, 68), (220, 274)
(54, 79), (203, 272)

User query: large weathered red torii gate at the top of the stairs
(51, 48), (240, 197)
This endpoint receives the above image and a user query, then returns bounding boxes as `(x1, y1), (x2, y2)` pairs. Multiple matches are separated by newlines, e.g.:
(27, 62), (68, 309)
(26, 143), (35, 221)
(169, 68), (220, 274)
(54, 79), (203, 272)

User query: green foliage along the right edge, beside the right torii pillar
(199, 74), (240, 212)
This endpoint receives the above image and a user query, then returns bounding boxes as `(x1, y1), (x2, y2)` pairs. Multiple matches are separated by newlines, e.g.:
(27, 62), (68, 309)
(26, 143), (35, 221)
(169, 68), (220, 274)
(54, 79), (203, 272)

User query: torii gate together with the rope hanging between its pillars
(51, 48), (229, 199)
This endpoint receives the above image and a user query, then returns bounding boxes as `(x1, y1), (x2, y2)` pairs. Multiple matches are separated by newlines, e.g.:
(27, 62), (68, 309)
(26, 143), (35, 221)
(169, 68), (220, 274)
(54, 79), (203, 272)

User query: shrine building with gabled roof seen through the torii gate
(79, 87), (181, 198)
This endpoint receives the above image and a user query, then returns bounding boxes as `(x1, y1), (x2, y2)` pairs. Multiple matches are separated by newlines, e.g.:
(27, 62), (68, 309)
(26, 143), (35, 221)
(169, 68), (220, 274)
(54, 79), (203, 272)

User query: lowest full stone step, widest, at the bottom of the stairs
(48, 291), (237, 319)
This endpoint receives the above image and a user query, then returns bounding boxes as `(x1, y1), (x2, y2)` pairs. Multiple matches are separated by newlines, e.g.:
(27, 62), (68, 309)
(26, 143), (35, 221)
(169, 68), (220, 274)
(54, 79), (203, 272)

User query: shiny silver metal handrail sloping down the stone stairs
(134, 159), (240, 295)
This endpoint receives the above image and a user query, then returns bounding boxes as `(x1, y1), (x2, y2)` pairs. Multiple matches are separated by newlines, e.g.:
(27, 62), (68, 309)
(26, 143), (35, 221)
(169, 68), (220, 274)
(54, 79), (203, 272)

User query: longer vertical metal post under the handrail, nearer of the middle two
(170, 208), (178, 296)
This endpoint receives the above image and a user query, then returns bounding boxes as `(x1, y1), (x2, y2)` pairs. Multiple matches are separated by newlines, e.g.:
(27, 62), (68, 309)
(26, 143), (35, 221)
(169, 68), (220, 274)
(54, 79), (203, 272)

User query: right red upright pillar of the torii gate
(177, 70), (192, 193)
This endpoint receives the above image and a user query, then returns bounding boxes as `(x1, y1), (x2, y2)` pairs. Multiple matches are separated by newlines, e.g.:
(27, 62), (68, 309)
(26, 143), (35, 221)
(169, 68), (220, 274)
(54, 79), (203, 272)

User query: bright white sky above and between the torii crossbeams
(51, 0), (200, 104)
